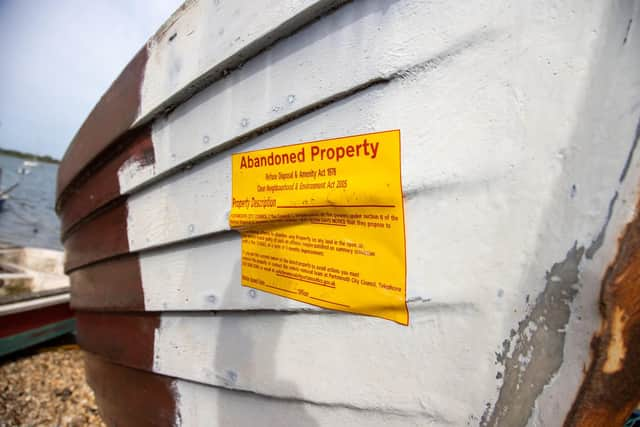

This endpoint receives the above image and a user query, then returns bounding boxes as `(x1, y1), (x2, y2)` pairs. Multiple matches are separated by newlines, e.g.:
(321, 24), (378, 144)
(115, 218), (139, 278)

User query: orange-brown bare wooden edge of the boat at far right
(564, 195), (640, 427)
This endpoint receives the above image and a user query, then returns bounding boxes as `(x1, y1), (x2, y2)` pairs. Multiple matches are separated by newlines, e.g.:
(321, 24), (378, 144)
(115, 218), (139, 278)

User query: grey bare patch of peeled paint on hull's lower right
(480, 244), (585, 427)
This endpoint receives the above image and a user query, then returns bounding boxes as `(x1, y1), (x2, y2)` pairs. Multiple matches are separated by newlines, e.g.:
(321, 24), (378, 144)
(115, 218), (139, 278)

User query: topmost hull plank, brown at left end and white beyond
(57, 0), (344, 202)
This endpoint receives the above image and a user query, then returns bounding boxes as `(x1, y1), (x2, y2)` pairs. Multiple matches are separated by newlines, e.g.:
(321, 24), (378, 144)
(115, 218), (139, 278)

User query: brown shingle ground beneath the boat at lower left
(0, 346), (104, 427)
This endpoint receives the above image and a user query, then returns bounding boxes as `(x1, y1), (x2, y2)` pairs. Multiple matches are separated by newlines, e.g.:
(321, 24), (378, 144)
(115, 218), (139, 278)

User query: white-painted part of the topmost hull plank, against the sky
(138, 0), (348, 122)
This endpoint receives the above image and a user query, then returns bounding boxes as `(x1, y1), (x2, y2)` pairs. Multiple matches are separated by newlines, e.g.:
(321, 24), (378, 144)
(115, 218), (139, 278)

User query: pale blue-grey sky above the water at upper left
(0, 0), (182, 159)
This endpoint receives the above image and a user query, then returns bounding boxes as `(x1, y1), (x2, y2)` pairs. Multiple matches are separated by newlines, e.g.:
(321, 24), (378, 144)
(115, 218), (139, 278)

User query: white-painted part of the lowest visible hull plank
(173, 380), (440, 427)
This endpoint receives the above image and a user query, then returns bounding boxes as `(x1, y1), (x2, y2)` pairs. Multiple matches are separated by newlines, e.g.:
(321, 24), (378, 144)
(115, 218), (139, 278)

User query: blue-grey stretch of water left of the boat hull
(0, 155), (62, 250)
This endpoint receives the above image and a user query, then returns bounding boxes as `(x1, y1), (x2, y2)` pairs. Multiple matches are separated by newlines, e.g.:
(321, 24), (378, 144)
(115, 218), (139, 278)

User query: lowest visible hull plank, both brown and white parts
(85, 353), (446, 427)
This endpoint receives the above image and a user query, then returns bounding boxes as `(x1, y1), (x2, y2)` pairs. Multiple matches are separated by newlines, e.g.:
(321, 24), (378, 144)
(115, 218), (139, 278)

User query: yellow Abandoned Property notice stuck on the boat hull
(229, 130), (409, 325)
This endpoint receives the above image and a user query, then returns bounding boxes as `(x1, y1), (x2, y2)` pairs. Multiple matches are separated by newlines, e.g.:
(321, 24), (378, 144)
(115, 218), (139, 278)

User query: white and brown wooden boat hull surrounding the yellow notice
(58, 0), (640, 426)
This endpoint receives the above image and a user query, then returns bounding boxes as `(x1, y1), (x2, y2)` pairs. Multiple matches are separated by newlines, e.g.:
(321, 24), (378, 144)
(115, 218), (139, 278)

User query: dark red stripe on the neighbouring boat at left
(0, 303), (73, 338)
